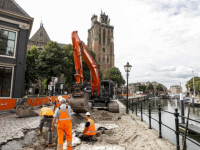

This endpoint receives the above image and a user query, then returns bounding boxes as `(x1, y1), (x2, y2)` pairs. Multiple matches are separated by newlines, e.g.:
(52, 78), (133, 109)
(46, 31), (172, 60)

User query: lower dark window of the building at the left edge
(0, 66), (12, 97)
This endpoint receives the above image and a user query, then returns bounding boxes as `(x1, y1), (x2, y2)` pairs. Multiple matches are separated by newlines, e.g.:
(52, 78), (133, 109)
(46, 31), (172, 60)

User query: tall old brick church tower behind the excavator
(87, 12), (115, 75)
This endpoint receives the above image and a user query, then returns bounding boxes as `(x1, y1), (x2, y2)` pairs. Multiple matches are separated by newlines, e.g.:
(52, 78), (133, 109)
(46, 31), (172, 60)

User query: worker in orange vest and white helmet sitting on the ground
(79, 112), (96, 141)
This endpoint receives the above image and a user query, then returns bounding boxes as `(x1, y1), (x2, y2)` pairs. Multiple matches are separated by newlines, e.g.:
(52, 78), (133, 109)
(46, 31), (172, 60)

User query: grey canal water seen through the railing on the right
(138, 99), (200, 150)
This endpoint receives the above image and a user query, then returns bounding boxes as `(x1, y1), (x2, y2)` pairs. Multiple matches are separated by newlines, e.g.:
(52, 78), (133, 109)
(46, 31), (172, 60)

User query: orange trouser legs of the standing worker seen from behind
(57, 121), (72, 150)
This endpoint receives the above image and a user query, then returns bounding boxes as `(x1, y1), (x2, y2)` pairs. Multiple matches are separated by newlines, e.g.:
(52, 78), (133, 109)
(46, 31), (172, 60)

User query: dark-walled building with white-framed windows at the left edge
(0, 0), (33, 98)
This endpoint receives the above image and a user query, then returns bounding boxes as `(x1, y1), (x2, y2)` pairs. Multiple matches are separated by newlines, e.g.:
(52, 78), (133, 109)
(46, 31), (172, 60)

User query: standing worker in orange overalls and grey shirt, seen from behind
(51, 98), (72, 150)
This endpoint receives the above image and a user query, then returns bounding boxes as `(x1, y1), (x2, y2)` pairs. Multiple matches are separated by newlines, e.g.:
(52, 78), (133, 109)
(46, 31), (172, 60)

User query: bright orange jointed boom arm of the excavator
(72, 31), (100, 96)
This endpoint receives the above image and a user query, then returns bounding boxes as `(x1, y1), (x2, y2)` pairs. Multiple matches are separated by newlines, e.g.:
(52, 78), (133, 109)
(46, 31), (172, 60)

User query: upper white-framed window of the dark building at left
(0, 29), (16, 57)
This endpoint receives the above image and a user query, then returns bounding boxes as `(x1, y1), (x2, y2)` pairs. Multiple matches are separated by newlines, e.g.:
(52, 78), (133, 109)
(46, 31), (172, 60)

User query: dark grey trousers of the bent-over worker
(39, 116), (53, 144)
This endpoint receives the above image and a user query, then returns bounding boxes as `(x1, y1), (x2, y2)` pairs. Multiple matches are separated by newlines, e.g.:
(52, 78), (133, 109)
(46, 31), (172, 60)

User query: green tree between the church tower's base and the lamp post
(105, 67), (125, 87)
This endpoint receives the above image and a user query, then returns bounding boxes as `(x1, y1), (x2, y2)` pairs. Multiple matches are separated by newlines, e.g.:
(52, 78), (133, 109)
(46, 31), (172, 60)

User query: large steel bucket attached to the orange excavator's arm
(70, 93), (90, 113)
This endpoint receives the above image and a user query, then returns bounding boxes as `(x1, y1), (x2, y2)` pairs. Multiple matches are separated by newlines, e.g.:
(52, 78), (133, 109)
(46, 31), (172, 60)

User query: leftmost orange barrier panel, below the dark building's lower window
(0, 99), (17, 111)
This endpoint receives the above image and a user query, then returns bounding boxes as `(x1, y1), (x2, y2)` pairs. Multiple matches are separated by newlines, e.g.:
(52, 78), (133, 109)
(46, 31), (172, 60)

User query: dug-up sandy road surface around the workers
(2, 102), (176, 150)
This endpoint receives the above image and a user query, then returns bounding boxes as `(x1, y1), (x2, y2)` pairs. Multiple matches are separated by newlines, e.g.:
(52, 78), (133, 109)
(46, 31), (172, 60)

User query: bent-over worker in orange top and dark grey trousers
(39, 106), (56, 147)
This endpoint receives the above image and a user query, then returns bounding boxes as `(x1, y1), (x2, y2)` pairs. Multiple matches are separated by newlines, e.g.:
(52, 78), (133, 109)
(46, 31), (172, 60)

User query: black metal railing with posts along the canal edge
(119, 99), (200, 150)
